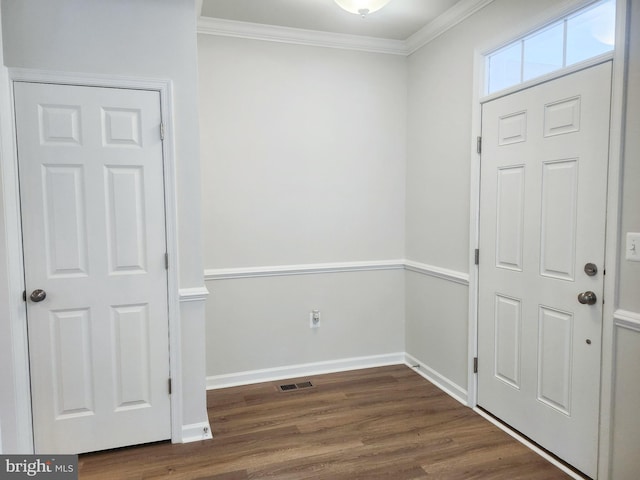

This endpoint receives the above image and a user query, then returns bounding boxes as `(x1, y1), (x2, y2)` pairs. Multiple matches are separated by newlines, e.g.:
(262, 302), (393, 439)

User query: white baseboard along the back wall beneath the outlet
(207, 353), (405, 390)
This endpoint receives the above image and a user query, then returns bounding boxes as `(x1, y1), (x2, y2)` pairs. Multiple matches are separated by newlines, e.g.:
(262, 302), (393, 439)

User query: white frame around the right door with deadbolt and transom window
(467, 0), (629, 480)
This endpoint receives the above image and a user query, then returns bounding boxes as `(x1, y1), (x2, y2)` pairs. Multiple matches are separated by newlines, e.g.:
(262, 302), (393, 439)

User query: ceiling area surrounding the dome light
(201, 0), (464, 41)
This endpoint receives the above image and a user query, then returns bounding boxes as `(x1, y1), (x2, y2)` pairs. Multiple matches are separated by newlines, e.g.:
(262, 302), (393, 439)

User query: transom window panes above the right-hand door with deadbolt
(485, 0), (616, 95)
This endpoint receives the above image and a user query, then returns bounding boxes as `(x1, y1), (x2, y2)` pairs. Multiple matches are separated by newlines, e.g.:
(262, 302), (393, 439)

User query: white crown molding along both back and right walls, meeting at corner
(197, 0), (493, 56)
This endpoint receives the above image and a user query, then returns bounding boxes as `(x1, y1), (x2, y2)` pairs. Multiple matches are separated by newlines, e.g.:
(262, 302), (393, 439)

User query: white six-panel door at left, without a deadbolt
(15, 83), (171, 453)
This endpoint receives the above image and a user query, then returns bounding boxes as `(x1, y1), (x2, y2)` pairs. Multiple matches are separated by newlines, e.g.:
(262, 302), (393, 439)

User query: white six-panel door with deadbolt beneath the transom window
(478, 62), (611, 477)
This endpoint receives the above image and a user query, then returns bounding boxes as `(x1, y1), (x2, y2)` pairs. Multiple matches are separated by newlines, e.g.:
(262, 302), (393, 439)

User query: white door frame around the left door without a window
(1, 68), (183, 453)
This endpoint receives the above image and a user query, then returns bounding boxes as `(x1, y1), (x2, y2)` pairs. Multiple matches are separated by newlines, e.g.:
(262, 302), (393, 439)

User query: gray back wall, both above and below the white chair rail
(198, 34), (406, 376)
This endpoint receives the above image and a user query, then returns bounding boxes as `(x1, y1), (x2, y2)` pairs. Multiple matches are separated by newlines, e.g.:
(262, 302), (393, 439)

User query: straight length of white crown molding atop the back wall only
(198, 17), (406, 55)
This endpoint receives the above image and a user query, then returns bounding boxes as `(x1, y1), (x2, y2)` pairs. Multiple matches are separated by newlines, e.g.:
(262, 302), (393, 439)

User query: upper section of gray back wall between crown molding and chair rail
(198, 34), (406, 268)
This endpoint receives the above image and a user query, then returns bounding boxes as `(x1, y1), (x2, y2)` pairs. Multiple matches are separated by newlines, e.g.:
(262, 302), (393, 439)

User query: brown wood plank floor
(79, 366), (569, 480)
